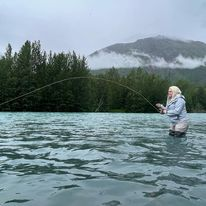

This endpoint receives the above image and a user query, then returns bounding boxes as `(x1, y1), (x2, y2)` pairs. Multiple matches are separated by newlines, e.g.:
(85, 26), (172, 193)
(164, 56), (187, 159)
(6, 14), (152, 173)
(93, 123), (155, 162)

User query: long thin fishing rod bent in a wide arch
(0, 76), (159, 112)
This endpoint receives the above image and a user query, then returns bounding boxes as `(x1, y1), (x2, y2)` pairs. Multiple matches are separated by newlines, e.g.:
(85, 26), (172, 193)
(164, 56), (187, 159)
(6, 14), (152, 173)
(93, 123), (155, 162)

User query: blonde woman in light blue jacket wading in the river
(156, 86), (188, 137)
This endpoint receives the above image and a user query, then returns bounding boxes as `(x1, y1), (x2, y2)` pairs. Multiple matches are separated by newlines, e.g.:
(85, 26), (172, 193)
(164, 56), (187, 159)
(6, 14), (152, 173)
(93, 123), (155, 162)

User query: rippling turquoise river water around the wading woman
(0, 112), (206, 206)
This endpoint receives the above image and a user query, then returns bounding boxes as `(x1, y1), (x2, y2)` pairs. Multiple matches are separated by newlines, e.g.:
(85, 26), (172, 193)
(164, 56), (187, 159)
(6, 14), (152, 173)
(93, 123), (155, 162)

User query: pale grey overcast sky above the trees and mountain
(0, 0), (206, 56)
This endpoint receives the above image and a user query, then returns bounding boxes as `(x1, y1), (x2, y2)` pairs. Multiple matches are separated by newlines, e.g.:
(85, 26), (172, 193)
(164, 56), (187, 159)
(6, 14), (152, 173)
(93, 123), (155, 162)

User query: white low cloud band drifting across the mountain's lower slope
(87, 51), (206, 69)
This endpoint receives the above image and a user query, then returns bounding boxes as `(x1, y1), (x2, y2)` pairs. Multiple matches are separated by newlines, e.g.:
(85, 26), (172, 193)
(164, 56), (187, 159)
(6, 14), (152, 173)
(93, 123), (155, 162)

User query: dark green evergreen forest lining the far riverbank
(0, 41), (206, 112)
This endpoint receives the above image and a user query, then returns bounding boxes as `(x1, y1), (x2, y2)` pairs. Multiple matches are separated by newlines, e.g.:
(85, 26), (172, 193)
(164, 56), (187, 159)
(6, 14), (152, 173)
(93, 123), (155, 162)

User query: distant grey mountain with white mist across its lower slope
(88, 36), (206, 69)
